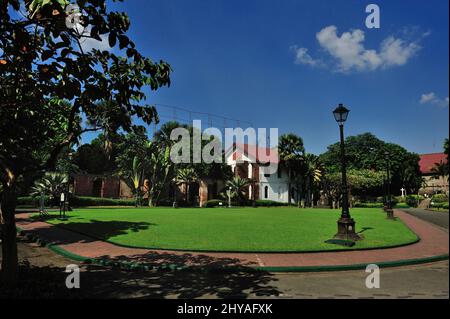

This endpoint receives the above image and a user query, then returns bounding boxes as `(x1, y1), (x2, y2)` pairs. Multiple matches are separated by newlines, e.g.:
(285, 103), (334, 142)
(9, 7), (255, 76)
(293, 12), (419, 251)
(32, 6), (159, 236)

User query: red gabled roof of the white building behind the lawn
(225, 143), (279, 164)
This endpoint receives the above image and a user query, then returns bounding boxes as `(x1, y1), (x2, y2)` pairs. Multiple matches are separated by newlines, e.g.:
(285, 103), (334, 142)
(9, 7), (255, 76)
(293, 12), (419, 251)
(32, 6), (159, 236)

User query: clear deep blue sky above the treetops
(84, 0), (449, 154)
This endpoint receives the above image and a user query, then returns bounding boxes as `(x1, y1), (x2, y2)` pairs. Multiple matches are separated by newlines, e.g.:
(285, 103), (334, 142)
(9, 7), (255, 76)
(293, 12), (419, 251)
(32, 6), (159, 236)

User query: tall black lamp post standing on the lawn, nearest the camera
(333, 104), (361, 240)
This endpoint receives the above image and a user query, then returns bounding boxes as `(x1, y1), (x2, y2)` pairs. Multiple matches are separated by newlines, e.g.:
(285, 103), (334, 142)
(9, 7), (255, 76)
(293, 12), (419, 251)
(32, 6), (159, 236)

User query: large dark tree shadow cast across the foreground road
(0, 238), (281, 299)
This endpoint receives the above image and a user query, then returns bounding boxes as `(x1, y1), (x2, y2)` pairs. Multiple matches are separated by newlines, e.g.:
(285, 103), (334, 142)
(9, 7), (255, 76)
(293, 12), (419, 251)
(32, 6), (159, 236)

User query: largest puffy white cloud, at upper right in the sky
(295, 25), (428, 73)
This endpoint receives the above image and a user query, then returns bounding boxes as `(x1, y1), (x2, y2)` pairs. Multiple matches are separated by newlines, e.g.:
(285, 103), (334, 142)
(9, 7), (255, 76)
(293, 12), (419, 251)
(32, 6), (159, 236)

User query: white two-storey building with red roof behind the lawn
(225, 144), (295, 203)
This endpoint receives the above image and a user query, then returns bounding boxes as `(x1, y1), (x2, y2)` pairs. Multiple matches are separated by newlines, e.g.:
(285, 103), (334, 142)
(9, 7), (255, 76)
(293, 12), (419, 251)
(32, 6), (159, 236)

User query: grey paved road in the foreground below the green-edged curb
(0, 237), (449, 299)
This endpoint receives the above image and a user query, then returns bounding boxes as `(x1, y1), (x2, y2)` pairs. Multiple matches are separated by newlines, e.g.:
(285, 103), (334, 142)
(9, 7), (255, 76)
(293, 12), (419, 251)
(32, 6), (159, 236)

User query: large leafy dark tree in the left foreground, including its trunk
(0, 0), (170, 286)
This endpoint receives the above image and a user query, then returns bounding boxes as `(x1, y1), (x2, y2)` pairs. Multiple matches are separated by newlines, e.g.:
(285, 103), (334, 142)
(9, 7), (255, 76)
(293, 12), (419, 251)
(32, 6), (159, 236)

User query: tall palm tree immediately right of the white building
(278, 134), (305, 205)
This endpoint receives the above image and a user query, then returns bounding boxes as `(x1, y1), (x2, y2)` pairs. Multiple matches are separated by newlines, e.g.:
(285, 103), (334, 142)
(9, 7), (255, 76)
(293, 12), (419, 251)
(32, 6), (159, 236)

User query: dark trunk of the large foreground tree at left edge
(1, 185), (18, 288)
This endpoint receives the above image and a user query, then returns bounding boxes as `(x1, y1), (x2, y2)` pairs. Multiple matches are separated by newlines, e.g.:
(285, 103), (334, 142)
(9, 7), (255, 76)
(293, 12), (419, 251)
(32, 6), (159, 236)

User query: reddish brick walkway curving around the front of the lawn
(16, 210), (449, 267)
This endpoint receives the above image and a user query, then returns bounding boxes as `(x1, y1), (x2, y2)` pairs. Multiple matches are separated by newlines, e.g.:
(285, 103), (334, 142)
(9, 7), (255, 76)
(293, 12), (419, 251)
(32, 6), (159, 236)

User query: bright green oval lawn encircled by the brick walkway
(43, 207), (417, 252)
